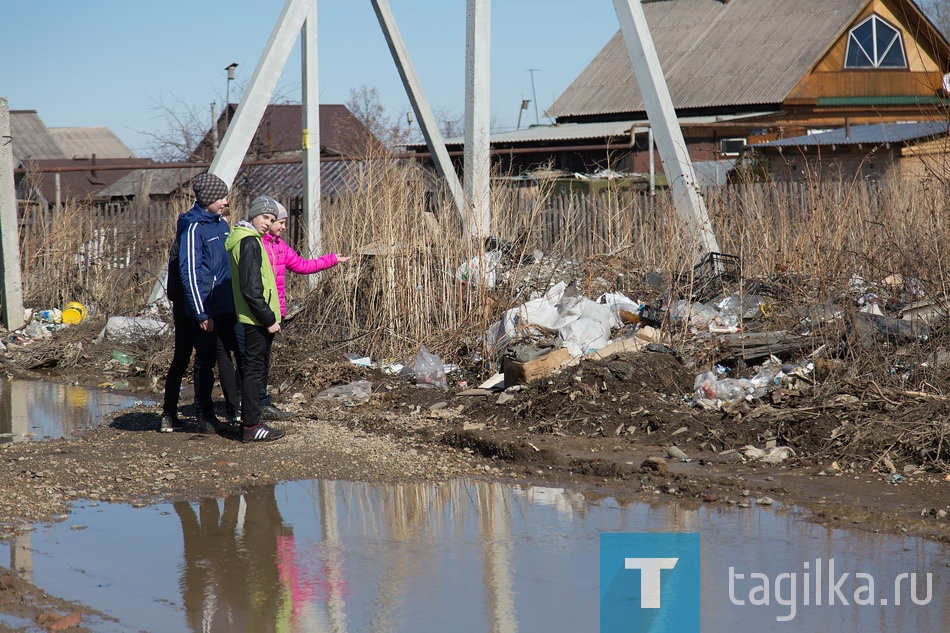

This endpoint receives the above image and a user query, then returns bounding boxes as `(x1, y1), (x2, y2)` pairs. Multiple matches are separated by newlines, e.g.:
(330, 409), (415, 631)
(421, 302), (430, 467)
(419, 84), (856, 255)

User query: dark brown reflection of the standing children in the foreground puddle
(174, 485), (293, 633)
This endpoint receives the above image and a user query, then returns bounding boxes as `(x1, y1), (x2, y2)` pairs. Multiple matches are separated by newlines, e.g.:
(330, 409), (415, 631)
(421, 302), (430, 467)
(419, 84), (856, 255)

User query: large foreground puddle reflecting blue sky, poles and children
(7, 480), (950, 633)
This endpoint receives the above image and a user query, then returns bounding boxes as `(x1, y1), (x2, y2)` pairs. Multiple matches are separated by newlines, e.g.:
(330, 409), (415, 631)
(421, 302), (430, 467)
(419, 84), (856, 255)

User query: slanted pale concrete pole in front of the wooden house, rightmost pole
(614, 0), (719, 253)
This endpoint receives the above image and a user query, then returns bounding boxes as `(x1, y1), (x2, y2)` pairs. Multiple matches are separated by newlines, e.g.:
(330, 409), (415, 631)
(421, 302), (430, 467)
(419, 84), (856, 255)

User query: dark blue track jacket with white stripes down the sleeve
(175, 204), (234, 322)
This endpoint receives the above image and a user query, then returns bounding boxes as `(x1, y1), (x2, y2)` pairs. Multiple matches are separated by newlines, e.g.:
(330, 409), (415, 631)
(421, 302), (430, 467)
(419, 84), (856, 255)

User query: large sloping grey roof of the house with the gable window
(546, 0), (869, 118)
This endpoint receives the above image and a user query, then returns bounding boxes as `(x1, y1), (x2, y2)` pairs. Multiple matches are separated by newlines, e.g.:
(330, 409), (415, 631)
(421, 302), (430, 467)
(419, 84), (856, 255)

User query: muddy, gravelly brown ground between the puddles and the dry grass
(0, 308), (950, 630)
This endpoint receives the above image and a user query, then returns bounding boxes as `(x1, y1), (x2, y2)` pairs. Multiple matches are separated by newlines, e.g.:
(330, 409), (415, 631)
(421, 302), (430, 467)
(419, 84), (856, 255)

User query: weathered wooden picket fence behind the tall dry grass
(20, 181), (943, 278)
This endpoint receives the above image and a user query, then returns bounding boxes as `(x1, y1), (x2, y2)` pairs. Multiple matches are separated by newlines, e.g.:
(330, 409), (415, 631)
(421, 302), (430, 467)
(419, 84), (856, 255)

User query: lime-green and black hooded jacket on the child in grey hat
(224, 222), (280, 327)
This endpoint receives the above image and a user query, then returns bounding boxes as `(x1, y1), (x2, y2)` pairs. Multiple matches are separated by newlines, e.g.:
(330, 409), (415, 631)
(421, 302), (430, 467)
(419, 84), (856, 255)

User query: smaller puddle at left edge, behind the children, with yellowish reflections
(0, 379), (149, 443)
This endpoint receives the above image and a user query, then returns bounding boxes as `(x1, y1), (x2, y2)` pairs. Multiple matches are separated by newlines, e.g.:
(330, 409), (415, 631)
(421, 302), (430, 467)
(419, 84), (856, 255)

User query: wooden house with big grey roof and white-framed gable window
(476, 0), (950, 178)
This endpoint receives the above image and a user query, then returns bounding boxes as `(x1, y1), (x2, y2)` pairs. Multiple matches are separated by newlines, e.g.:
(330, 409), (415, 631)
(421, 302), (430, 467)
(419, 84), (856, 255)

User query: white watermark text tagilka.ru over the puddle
(729, 558), (933, 622)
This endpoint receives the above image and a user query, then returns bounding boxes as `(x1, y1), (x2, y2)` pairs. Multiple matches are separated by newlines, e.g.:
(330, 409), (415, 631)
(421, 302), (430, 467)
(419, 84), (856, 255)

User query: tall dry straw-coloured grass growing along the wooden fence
(21, 159), (950, 370)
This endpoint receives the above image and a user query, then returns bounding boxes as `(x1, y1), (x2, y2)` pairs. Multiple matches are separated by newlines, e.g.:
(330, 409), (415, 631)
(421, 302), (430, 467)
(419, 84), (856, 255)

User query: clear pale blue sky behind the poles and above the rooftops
(0, 0), (619, 157)
